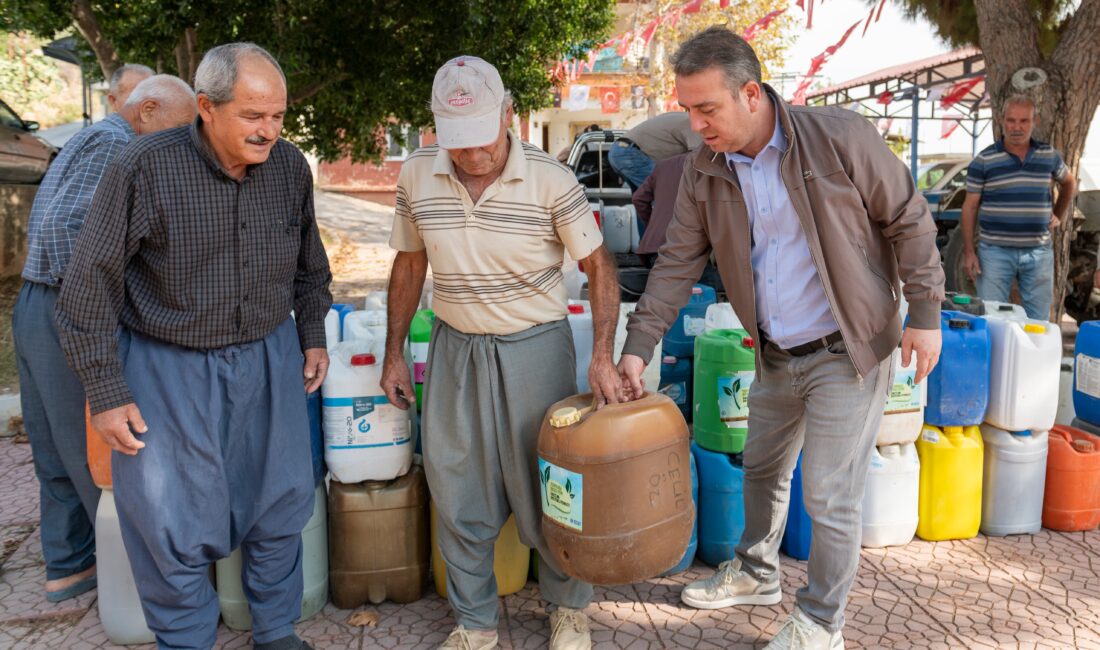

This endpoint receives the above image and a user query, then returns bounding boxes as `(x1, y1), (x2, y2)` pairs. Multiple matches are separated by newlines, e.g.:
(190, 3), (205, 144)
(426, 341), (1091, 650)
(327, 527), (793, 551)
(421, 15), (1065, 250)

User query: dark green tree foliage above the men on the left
(0, 0), (614, 161)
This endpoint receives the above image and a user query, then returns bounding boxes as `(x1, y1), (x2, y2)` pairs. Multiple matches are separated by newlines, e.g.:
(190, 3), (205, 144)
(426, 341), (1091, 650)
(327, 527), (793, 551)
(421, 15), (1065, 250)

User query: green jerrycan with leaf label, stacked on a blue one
(693, 330), (756, 453)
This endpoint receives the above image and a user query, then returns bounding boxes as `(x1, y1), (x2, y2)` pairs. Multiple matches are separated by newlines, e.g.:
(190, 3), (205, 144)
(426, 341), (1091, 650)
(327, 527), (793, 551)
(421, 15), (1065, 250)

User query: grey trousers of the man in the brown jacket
(737, 342), (893, 630)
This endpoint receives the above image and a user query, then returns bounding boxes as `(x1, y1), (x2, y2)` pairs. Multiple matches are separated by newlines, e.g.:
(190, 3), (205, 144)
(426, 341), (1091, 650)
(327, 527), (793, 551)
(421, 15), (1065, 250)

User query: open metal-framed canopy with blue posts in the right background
(806, 47), (992, 181)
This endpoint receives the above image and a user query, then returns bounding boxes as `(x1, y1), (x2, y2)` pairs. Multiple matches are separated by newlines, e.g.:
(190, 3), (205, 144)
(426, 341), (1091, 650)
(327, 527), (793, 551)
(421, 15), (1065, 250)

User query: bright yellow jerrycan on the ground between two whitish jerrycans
(916, 425), (983, 541)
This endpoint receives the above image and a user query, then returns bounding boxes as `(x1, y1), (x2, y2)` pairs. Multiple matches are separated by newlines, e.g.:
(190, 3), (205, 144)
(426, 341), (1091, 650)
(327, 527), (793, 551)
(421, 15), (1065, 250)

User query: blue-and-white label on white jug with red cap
(321, 395), (413, 450)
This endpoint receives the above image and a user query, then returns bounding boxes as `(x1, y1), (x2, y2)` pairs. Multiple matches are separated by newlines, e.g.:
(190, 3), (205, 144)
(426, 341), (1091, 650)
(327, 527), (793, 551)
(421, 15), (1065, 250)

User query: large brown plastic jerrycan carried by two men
(538, 393), (695, 585)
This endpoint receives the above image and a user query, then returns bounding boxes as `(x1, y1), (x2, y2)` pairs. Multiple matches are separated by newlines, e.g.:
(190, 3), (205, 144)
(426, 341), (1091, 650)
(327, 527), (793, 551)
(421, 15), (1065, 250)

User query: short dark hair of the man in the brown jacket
(669, 25), (762, 95)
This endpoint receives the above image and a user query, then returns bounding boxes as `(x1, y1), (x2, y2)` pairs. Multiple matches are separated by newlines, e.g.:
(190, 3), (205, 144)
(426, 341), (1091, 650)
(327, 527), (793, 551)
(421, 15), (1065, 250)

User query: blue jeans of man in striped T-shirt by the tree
(978, 242), (1054, 320)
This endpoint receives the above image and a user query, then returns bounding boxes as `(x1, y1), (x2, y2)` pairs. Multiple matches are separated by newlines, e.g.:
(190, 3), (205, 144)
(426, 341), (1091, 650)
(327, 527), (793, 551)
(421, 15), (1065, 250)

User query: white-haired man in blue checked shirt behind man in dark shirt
(12, 75), (196, 602)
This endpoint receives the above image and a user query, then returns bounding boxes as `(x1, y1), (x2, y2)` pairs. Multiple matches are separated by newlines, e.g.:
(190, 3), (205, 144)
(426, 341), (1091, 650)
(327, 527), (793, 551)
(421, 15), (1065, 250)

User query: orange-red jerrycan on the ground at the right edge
(1043, 425), (1100, 531)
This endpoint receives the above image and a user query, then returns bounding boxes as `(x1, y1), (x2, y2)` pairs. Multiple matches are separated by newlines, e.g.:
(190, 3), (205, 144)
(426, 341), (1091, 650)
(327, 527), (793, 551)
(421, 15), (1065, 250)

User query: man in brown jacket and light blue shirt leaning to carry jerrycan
(619, 27), (944, 650)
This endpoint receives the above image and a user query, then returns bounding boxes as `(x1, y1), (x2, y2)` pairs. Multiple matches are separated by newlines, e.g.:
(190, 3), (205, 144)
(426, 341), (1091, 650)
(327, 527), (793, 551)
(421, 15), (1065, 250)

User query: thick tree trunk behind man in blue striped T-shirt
(975, 0), (1100, 322)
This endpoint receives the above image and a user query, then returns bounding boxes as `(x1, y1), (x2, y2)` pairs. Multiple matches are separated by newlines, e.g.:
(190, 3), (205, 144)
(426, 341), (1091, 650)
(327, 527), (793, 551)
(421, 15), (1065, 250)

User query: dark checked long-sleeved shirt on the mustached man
(57, 120), (332, 412)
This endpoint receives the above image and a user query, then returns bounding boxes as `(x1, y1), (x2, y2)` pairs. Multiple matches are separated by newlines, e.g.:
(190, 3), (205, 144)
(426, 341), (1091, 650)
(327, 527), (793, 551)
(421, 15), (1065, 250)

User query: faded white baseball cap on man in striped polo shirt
(431, 56), (505, 148)
